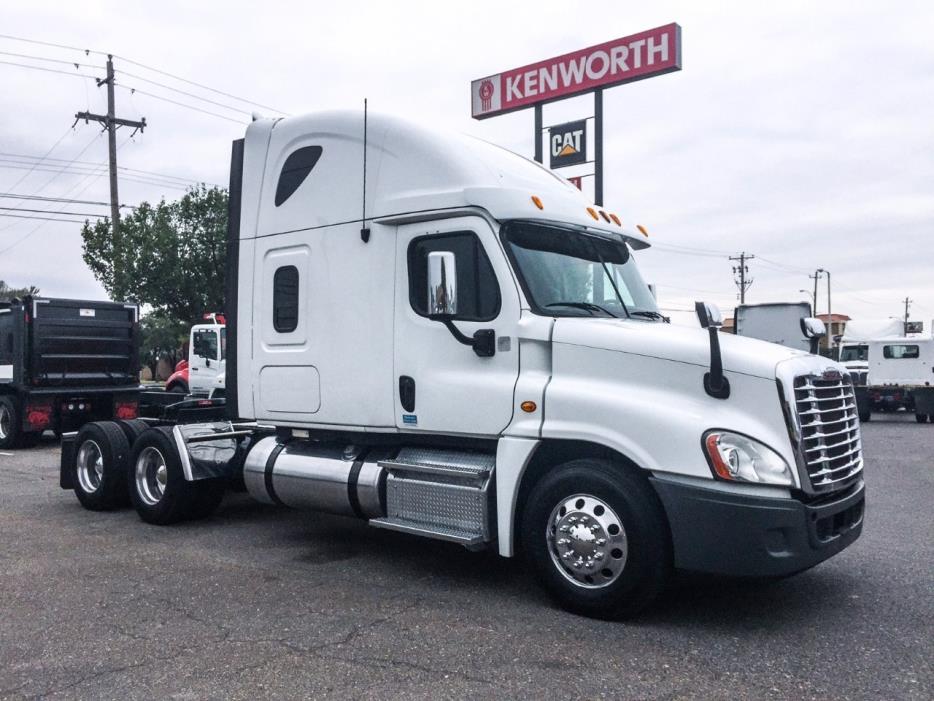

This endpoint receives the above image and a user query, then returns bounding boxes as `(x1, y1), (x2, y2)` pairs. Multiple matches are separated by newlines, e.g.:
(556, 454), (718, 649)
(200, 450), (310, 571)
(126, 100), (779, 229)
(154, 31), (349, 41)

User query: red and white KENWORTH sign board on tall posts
(470, 23), (681, 119)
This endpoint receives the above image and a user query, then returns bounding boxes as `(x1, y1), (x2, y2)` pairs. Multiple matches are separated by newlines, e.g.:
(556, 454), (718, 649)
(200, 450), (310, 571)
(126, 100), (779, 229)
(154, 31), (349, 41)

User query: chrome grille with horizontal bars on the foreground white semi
(794, 373), (863, 492)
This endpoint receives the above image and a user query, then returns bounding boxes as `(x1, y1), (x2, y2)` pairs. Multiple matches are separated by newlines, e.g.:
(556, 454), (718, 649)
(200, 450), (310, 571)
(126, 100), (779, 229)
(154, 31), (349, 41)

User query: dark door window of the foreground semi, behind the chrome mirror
(408, 231), (500, 321)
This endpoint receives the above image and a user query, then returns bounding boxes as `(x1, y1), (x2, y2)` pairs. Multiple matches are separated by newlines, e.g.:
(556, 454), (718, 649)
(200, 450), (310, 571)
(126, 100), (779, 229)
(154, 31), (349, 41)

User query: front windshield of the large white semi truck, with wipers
(502, 222), (662, 320)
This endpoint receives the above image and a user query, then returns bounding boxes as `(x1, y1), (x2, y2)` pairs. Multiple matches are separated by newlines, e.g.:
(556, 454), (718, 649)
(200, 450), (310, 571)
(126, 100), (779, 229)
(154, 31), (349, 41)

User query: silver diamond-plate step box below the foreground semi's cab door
(370, 448), (496, 548)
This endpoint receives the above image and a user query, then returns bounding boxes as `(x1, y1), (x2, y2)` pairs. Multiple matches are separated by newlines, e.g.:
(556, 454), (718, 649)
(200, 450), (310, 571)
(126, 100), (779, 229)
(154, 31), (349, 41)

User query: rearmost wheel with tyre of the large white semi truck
(72, 421), (130, 511)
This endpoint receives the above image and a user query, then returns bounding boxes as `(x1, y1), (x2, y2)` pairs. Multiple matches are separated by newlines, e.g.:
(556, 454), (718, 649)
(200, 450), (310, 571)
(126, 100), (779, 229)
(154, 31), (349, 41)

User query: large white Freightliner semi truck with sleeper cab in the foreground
(61, 112), (864, 617)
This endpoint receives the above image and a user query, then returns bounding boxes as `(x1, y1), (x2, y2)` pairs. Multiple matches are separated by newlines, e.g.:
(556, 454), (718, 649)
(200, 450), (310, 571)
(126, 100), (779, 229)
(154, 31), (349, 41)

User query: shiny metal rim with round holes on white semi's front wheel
(545, 494), (629, 589)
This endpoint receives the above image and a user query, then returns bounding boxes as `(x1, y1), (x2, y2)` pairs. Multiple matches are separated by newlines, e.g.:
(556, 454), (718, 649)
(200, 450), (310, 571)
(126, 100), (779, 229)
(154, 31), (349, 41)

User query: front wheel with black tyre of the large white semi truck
(520, 458), (672, 619)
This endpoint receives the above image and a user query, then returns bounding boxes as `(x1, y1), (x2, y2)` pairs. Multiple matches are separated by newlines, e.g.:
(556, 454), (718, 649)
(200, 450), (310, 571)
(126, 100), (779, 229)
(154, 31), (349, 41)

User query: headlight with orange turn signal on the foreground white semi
(704, 431), (794, 487)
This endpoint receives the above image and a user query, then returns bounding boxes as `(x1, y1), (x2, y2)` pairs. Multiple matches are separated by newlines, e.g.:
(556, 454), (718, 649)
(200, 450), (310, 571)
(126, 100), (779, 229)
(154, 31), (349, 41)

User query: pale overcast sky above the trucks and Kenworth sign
(0, 0), (934, 329)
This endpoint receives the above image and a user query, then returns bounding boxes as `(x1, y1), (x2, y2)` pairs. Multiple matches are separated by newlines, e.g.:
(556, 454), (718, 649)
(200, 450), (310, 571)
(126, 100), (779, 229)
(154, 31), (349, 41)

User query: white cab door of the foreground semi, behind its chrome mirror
(394, 217), (520, 436)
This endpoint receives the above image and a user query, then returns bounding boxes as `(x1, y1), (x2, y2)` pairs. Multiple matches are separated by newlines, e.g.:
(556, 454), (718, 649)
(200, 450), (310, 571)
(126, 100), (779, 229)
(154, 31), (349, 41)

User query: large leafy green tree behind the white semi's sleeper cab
(81, 185), (227, 324)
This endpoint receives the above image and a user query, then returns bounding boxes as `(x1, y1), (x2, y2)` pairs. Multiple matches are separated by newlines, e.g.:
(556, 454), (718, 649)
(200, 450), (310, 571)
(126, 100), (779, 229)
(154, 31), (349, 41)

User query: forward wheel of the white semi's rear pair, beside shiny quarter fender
(130, 426), (224, 526)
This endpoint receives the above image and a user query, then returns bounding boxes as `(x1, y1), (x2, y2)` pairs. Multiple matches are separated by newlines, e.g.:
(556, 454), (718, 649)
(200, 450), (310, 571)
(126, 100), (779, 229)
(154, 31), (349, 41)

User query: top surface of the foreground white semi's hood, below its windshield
(552, 317), (812, 380)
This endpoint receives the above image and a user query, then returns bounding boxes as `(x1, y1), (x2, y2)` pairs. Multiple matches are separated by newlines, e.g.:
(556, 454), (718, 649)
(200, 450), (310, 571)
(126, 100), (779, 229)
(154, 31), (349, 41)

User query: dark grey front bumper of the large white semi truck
(650, 477), (865, 577)
